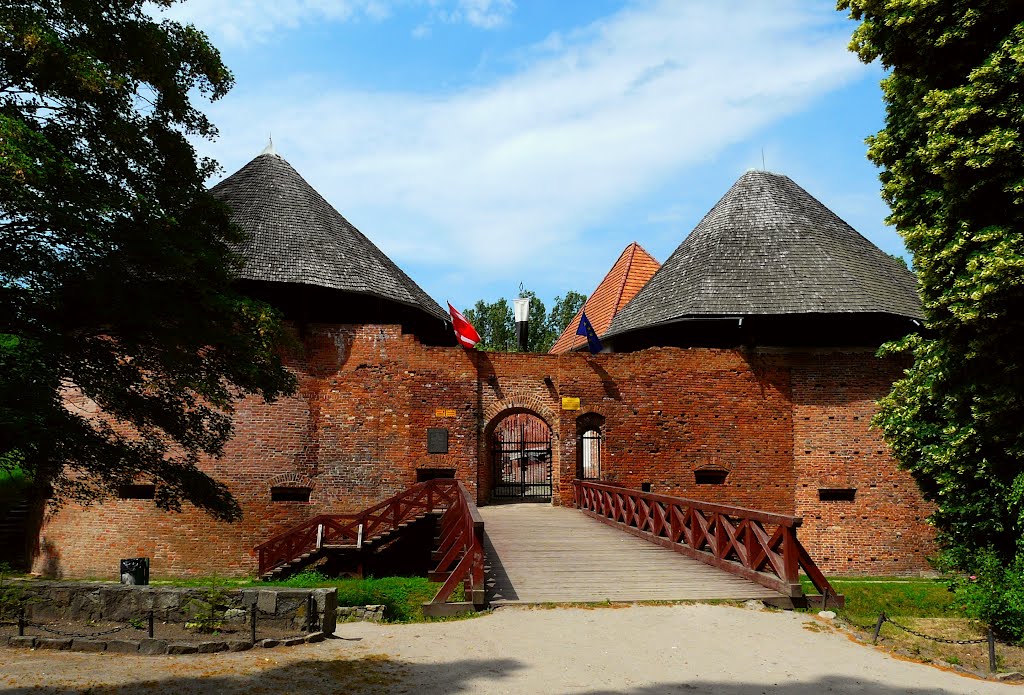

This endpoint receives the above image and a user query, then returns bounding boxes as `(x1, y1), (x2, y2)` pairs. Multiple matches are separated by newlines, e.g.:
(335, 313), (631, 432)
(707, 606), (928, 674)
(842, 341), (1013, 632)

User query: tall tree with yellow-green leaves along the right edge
(839, 0), (1024, 630)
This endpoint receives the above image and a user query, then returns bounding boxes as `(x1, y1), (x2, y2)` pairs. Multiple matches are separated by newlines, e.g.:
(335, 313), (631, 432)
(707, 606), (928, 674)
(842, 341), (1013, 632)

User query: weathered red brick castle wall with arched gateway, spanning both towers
(35, 325), (929, 578)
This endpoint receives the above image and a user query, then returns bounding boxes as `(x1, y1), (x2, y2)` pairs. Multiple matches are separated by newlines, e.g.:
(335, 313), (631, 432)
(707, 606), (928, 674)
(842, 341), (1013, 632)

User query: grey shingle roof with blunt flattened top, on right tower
(602, 171), (922, 337)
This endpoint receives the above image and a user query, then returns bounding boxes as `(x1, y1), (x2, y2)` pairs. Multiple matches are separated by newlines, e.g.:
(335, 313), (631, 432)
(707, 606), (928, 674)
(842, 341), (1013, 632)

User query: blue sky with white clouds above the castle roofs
(154, 0), (903, 308)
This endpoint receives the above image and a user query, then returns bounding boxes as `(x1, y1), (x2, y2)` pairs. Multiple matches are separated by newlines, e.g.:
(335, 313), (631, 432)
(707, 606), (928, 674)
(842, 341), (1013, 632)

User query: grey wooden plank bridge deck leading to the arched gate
(480, 504), (779, 605)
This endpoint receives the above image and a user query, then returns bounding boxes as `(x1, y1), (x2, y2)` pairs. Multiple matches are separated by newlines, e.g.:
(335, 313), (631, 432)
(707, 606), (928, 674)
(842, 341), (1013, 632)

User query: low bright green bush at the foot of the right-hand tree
(949, 551), (1024, 643)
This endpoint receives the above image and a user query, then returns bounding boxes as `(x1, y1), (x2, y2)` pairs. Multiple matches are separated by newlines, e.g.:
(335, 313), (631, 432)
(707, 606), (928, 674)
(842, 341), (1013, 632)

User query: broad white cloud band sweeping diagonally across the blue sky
(195, 0), (862, 291)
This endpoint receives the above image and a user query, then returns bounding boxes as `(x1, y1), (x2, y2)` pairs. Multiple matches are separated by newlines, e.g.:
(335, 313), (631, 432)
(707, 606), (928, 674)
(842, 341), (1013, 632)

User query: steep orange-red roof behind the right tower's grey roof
(549, 242), (660, 354)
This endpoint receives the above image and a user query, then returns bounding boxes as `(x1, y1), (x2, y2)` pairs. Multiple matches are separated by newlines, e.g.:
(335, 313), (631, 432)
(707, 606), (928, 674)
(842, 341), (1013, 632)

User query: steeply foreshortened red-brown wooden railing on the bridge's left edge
(424, 483), (486, 615)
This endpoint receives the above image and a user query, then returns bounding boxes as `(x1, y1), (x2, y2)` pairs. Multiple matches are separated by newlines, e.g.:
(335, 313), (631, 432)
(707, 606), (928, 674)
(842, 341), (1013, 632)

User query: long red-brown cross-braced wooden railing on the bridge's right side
(572, 480), (843, 605)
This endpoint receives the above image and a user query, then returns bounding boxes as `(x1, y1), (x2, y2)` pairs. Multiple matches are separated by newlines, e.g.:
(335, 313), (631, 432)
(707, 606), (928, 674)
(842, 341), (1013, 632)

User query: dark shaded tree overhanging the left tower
(0, 0), (295, 519)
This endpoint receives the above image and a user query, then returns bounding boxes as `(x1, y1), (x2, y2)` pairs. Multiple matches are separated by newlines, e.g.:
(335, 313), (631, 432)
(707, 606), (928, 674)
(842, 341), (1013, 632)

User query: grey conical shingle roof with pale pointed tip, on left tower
(211, 148), (447, 320)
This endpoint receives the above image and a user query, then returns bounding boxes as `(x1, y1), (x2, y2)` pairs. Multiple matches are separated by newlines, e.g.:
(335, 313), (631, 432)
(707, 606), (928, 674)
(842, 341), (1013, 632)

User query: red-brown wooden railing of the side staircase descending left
(254, 479), (465, 575)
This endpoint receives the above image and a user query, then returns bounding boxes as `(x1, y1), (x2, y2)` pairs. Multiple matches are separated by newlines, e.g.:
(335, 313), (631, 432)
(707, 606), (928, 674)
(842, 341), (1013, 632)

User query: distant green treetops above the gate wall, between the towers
(462, 290), (587, 352)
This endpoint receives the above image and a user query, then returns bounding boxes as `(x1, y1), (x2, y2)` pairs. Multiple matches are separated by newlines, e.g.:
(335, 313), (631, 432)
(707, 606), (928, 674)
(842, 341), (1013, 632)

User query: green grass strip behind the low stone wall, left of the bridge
(151, 571), (463, 622)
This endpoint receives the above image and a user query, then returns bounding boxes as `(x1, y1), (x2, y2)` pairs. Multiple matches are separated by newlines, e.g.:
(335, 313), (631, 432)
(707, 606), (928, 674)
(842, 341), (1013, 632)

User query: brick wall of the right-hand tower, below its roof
(788, 351), (935, 575)
